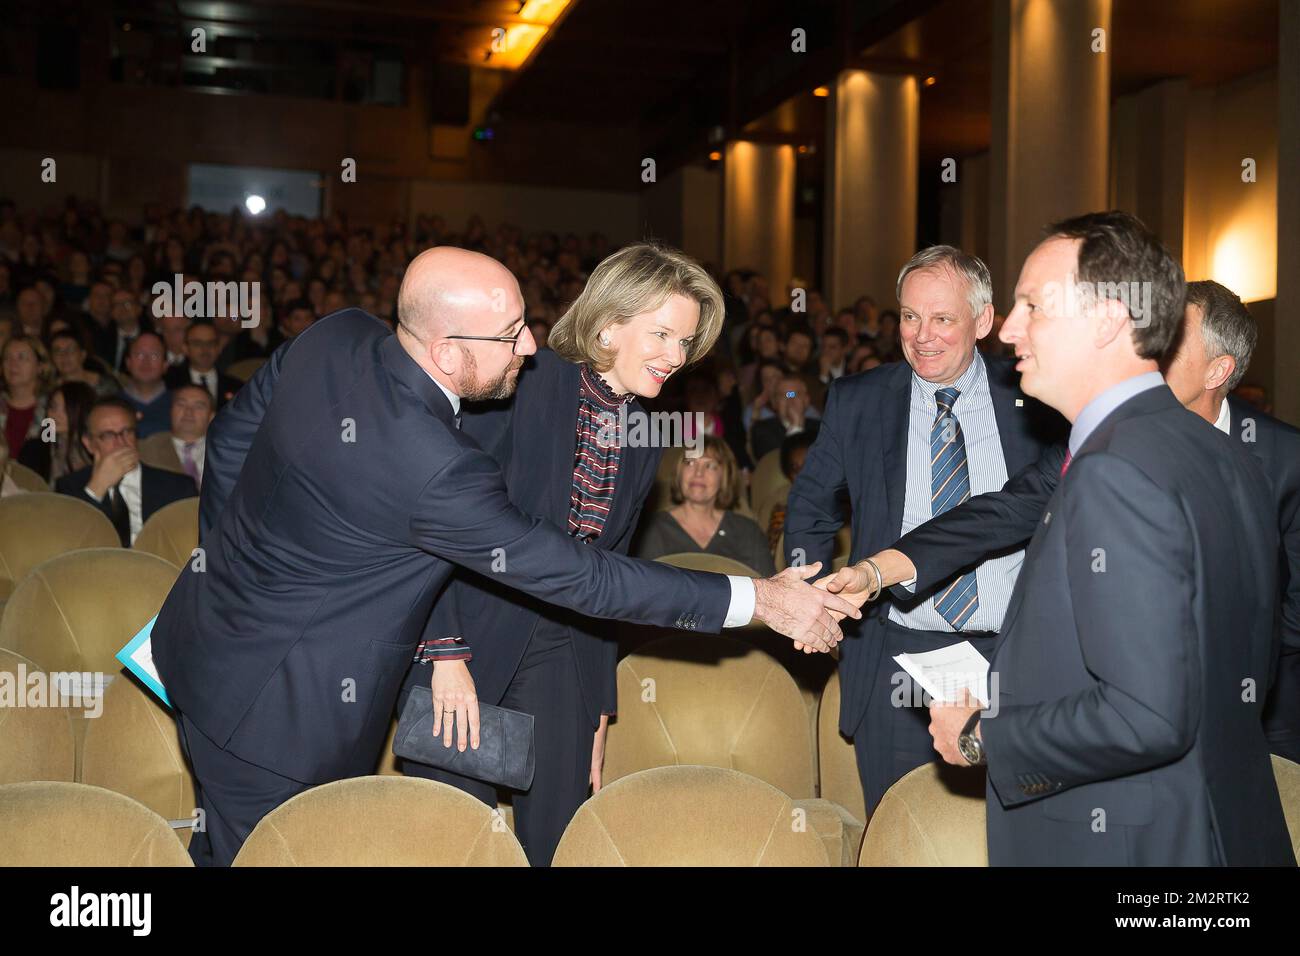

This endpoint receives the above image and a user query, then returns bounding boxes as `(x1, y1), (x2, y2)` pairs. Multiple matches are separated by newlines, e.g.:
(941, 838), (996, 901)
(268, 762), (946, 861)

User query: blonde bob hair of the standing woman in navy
(546, 242), (723, 372)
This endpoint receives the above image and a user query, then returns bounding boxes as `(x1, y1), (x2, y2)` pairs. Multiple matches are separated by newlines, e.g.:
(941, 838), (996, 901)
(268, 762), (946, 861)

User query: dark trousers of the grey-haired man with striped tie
(853, 620), (997, 816)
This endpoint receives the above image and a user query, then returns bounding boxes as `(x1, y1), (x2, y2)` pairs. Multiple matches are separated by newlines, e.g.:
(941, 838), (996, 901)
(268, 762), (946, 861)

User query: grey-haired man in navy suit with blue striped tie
(785, 246), (1063, 813)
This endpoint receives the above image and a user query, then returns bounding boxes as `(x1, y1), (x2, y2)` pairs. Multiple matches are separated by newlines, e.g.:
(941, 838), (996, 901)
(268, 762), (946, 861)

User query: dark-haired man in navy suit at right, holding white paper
(931, 212), (1295, 866)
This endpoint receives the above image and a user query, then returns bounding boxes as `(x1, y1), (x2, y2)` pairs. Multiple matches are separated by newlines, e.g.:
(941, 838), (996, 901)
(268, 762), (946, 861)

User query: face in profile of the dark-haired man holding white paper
(998, 237), (1095, 421)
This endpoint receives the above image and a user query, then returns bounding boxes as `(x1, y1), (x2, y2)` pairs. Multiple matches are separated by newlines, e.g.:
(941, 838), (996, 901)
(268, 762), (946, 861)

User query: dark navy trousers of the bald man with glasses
(177, 714), (311, 866)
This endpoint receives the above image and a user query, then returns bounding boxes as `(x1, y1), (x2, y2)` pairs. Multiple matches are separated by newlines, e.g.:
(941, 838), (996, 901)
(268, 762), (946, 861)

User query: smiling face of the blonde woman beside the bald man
(601, 294), (699, 398)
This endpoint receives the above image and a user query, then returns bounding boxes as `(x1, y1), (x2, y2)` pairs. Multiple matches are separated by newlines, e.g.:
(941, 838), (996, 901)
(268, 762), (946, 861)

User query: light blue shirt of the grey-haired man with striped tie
(889, 351), (1024, 632)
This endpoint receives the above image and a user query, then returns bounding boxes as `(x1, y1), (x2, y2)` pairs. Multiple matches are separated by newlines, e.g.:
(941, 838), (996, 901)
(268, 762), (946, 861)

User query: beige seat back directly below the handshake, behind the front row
(605, 632), (862, 865)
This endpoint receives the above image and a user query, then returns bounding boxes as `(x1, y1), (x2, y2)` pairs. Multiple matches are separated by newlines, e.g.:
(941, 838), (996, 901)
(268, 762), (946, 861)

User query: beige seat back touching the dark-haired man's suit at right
(858, 763), (988, 866)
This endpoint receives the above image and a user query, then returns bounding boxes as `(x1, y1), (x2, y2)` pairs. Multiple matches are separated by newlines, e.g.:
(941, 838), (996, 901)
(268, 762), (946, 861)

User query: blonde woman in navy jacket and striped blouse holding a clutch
(400, 245), (723, 866)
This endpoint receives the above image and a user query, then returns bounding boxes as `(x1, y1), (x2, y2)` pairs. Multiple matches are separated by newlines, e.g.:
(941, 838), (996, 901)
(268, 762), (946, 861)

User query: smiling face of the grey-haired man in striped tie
(898, 267), (993, 385)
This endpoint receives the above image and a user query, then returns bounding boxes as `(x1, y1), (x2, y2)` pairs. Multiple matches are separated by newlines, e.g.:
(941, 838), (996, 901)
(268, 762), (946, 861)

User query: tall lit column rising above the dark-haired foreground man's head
(988, 0), (1113, 306)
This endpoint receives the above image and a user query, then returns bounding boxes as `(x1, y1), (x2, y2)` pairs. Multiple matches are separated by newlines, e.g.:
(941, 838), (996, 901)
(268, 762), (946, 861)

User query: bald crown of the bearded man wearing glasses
(398, 246), (524, 339)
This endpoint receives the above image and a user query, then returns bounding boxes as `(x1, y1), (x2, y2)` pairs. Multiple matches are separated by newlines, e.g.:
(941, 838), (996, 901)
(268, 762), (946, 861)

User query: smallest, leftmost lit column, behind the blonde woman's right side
(723, 140), (794, 306)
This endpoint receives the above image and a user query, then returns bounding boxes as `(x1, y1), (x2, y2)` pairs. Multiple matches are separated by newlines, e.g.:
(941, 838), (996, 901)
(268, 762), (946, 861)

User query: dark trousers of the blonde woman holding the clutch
(400, 620), (595, 866)
